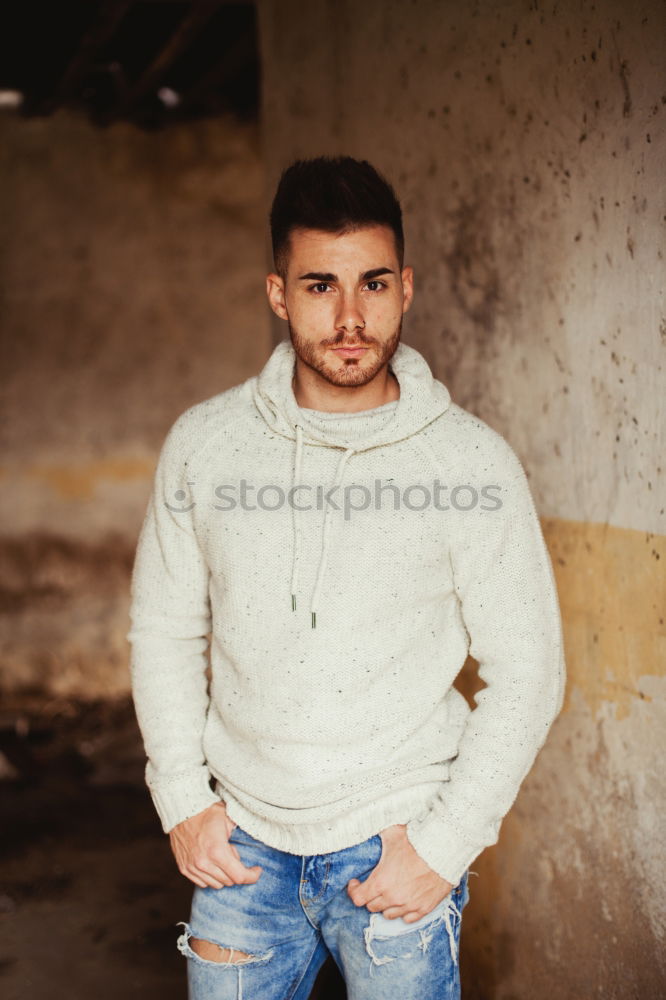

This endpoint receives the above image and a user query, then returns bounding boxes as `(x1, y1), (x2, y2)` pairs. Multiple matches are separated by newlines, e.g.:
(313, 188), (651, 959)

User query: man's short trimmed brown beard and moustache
(289, 317), (402, 387)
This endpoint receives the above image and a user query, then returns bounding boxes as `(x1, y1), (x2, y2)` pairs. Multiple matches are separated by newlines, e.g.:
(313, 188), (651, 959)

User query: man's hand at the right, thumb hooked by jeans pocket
(347, 825), (453, 924)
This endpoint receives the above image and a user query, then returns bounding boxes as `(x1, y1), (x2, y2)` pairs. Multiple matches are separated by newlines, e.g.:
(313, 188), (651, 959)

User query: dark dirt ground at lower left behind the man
(0, 697), (345, 1000)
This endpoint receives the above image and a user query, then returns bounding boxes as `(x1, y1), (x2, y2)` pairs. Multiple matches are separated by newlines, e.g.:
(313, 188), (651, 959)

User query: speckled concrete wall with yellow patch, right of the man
(260, 0), (666, 1000)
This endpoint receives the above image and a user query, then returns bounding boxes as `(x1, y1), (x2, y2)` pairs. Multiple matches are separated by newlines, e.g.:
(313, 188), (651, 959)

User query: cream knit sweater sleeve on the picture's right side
(407, 433), (565, 885)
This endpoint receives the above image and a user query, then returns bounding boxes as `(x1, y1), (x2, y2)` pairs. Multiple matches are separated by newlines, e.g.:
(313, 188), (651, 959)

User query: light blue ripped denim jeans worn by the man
(178, 827), (469, 1000)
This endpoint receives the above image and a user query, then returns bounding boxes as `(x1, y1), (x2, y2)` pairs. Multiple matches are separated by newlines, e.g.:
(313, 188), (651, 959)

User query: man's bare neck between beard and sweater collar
(291, 361), (400, 413)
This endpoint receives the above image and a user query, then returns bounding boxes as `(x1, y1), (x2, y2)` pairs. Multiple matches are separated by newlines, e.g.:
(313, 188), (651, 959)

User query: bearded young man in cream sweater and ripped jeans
(129, 157), (564, 1000)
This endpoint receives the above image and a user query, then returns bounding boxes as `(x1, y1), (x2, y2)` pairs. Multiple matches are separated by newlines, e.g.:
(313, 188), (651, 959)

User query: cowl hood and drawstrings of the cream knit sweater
(253, 340), (451, 628)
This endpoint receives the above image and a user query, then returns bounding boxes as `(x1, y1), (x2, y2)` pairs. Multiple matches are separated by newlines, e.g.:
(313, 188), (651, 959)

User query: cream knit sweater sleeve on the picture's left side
(127, 414), (219, 832)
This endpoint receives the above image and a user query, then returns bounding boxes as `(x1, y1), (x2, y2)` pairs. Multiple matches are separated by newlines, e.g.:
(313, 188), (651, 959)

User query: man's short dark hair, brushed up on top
(270, 156), (405, 277)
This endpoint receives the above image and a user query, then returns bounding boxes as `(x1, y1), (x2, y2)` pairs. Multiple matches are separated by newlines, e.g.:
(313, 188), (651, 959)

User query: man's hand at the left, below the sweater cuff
(169, 802), (262, 889)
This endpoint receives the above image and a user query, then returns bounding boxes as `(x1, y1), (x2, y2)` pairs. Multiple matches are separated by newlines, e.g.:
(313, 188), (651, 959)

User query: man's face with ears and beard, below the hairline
(267, 226), (413, 387)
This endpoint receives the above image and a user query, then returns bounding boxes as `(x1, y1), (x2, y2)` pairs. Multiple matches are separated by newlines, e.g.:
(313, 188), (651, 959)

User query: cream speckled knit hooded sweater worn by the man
(128, 341), (565, 884)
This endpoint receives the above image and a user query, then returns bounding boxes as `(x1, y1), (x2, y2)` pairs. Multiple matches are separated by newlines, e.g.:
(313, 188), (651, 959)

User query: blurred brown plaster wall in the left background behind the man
(0, 114), (270, 697)
